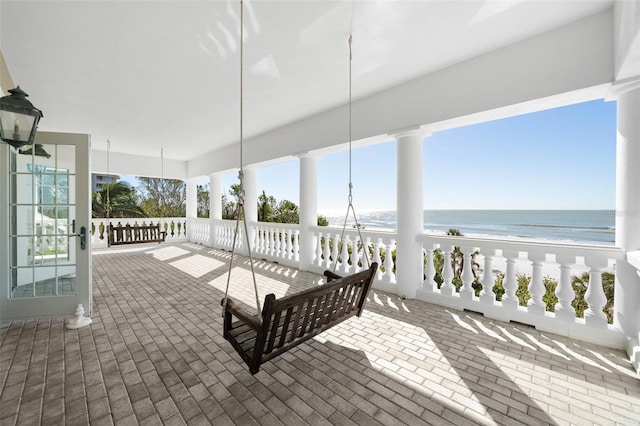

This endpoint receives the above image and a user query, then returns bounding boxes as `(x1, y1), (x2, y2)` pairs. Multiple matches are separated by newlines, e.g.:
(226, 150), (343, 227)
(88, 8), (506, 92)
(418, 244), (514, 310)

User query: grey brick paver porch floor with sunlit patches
(0, 243), (640, 426)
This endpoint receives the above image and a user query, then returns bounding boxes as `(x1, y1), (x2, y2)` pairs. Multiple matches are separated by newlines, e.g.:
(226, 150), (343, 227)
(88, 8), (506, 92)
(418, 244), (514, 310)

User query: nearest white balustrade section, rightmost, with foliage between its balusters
(416, 234), (625, 343)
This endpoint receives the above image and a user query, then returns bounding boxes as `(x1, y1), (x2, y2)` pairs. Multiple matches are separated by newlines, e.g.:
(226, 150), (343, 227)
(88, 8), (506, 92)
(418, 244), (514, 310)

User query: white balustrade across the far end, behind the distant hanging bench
(90, 217), (187, 248)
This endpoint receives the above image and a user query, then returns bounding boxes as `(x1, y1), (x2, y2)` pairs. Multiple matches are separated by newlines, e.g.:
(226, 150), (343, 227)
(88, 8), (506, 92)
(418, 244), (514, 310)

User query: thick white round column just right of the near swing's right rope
(393, 129), (427, 299)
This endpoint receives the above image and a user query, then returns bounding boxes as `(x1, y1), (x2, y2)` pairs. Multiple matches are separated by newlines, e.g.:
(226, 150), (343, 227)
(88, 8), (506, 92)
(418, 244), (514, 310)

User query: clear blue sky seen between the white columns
(122, 100), (616, 215)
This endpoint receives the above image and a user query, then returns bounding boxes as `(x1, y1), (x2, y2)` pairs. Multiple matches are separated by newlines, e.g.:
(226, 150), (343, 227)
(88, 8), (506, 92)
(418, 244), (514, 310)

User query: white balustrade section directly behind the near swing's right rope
(312, 226), (396, 293)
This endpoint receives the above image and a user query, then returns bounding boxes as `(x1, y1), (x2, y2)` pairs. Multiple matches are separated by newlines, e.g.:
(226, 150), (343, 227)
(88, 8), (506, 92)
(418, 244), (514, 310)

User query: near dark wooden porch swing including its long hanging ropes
(221, 0), (378, 374)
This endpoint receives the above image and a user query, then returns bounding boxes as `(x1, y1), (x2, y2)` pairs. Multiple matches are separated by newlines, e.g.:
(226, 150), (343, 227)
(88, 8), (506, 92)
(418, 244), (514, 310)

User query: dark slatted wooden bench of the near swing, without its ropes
(221, 262), (378, 374)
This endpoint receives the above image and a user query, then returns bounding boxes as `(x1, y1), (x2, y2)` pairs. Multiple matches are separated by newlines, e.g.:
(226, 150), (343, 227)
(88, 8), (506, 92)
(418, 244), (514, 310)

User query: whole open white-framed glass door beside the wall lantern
(0, 132), (91, 320)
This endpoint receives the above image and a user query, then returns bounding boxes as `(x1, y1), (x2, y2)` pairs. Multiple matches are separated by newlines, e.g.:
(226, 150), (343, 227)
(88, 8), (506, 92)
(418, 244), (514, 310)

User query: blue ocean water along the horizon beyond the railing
(325, 210), (615, 245)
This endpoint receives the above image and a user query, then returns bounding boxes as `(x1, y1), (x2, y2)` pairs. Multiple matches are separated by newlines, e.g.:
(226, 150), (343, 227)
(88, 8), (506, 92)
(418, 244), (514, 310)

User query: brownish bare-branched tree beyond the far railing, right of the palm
(137, 177), (187, 217)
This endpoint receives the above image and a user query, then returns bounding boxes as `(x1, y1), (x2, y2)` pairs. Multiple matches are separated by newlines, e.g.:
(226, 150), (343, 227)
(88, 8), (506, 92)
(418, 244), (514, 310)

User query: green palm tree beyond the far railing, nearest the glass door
(91, 182), (147, 218)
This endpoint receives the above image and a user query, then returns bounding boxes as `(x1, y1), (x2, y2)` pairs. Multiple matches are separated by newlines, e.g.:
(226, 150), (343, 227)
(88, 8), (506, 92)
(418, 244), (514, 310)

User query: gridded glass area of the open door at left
(10, 144), (76, 298)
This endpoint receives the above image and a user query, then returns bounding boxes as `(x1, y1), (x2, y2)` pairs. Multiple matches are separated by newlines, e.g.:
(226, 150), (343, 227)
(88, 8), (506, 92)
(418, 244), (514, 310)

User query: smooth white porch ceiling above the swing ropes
(0, 0), (613, 160)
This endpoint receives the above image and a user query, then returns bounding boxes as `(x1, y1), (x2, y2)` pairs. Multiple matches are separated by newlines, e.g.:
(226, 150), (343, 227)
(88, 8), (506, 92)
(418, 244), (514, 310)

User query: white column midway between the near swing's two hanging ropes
(298, 154), (318, 271)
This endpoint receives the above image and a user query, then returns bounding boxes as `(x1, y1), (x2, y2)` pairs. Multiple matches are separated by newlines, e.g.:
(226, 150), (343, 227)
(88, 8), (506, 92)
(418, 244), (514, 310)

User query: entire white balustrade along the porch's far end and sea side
(91, 218), (625, 346)
